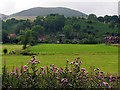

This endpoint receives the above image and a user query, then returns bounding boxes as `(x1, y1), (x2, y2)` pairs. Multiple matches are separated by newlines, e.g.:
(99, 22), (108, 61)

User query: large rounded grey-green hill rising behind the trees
(10, 7), (88, 17)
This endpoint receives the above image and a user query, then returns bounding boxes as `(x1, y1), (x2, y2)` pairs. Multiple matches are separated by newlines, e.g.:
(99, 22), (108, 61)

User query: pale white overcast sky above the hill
(0, 0), (119, 16)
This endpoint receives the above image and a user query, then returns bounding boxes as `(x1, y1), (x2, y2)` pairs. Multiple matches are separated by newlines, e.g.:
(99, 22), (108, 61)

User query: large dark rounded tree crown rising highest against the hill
(44, 14), (65, 33)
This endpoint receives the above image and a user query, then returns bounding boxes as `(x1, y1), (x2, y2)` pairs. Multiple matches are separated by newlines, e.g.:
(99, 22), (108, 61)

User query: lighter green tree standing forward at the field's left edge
(20, 28), (33, 49)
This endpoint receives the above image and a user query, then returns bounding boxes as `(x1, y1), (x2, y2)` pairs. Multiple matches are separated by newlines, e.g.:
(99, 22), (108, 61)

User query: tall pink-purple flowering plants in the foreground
(2, 56), (120, 89)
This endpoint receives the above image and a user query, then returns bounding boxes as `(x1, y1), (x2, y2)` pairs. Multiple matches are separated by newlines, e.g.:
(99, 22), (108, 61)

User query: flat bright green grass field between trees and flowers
(2, 44), (118, 73)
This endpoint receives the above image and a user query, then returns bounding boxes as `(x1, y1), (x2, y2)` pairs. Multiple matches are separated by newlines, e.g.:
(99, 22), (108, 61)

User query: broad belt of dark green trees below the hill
(2, 14), (119, 47)
